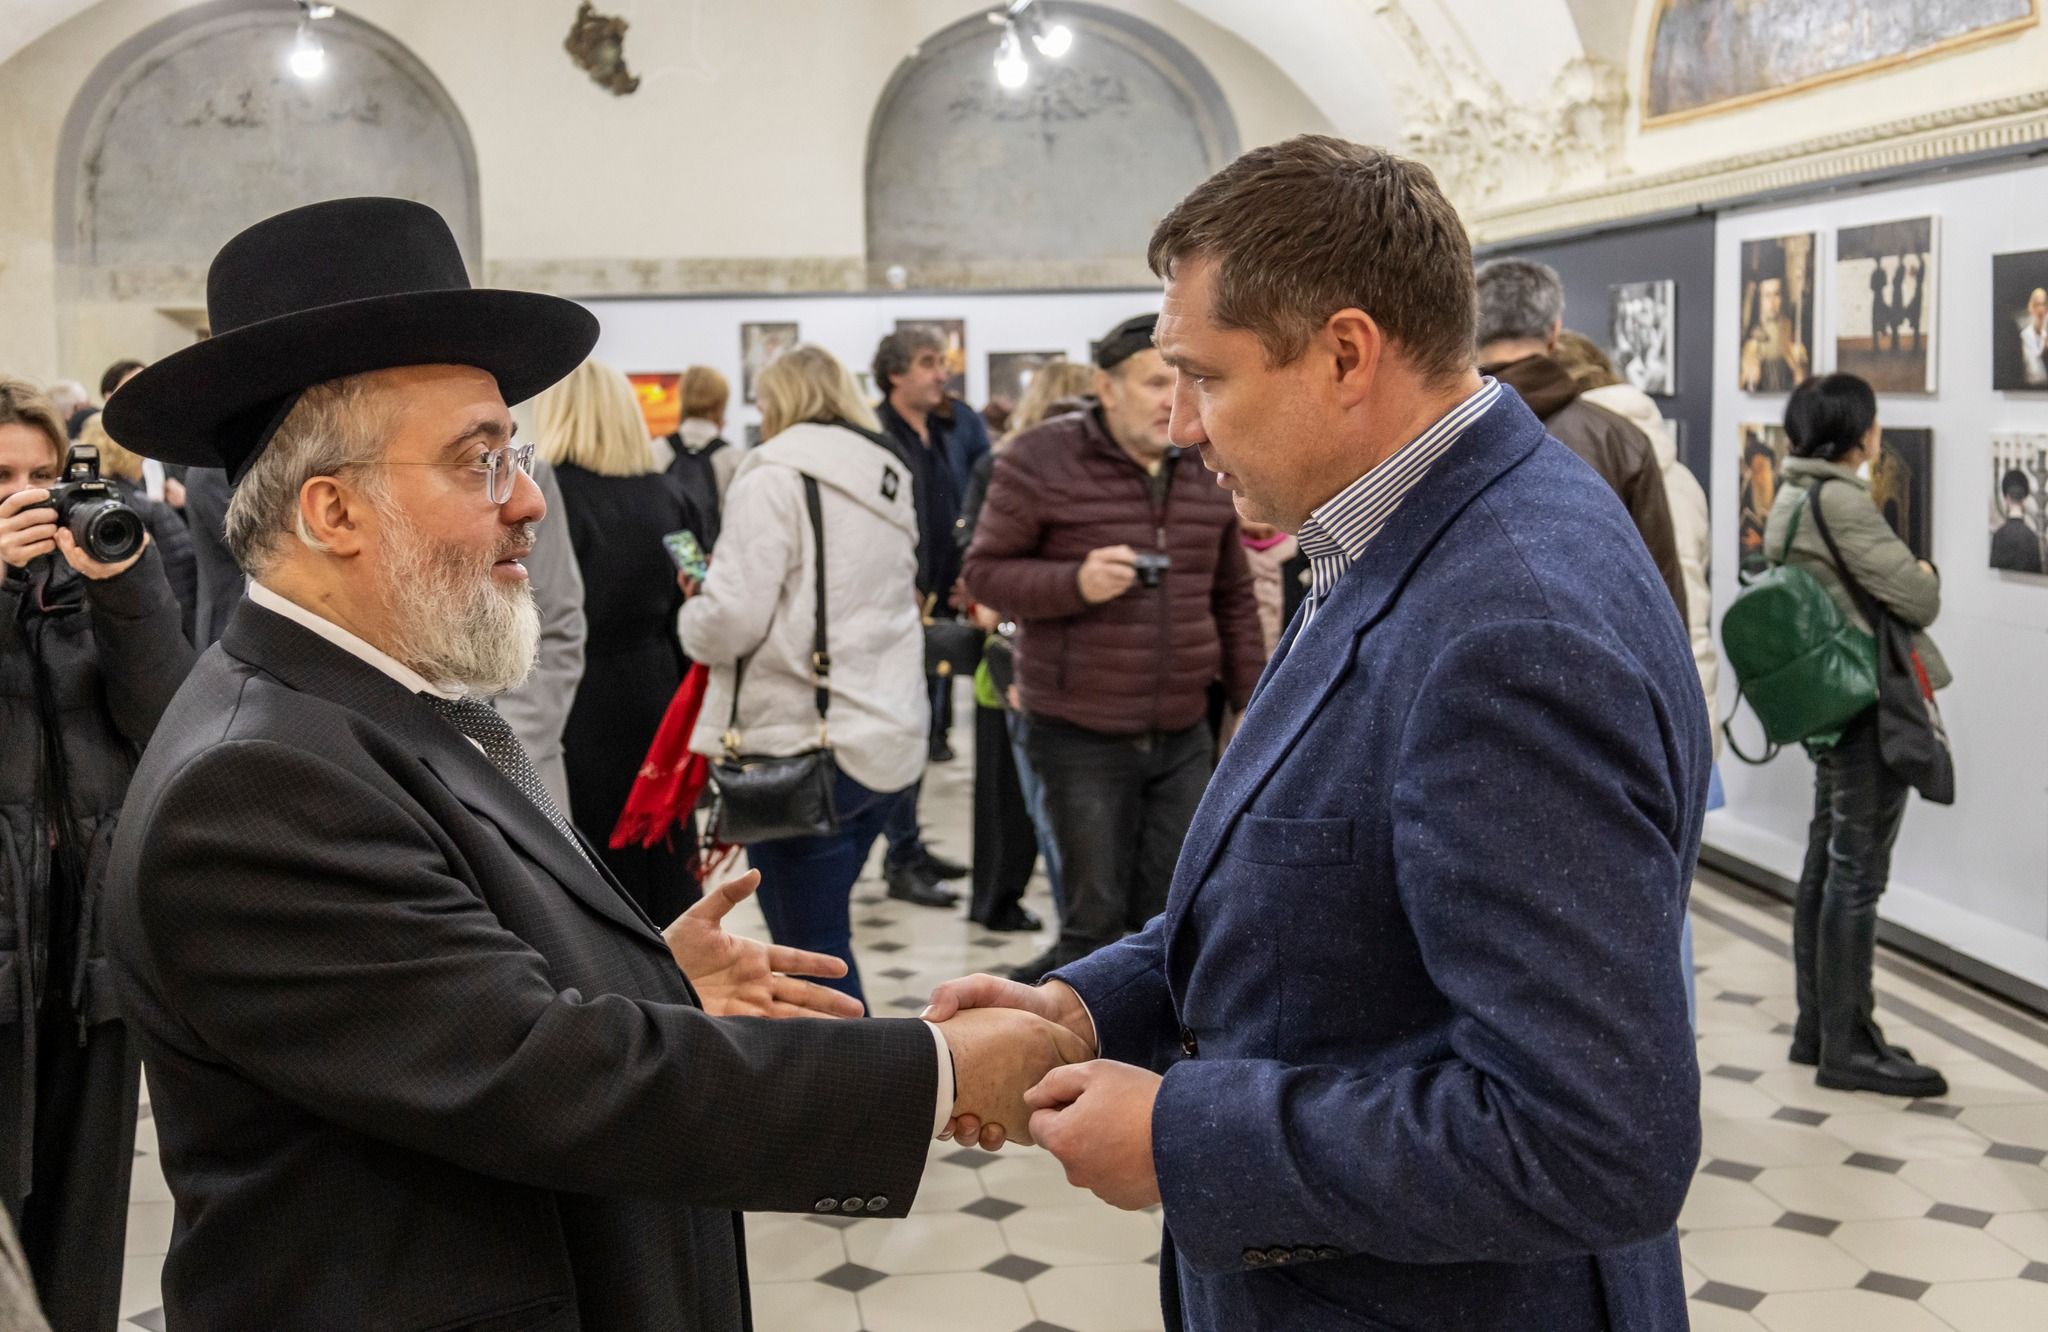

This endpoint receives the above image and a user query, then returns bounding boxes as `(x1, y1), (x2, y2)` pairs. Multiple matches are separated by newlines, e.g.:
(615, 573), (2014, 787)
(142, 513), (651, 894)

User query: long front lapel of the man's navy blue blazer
(1167, 393), (1544, 947)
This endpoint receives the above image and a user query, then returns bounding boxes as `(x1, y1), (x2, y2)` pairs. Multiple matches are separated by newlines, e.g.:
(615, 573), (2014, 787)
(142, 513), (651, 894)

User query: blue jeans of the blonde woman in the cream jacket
(748, 773), (901, 1004)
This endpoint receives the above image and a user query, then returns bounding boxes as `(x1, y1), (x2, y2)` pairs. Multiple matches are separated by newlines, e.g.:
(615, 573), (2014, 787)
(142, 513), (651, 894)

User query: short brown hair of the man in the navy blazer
(1145, 133), (1477, 379)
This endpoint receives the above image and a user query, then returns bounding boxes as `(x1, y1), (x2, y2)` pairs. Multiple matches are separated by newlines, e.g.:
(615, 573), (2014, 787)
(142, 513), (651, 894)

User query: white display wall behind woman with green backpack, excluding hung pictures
(1706, 166), (2048, 984)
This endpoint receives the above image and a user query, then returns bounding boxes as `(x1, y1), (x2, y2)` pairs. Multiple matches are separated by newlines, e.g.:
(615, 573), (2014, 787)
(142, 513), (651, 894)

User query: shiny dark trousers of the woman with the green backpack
(1792, 709), (1909, 1064)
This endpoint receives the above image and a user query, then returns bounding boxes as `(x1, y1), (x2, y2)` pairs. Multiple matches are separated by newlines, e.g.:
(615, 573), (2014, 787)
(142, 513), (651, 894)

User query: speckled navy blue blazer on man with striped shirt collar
(1057, 393), (1710, 1332)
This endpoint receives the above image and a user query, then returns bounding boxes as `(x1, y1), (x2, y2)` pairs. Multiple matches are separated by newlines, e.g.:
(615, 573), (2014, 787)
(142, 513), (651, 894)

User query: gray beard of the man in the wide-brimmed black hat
(381, 504), (541, 695)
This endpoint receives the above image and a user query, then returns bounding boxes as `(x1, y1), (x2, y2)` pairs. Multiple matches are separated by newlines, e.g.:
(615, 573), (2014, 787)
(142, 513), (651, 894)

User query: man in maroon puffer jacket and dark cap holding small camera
(967, 316), (1266, 982)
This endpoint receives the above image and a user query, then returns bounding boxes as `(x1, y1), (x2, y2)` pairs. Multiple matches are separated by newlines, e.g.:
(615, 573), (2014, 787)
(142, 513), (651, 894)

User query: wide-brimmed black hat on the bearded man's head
(104, 199), (598, 480)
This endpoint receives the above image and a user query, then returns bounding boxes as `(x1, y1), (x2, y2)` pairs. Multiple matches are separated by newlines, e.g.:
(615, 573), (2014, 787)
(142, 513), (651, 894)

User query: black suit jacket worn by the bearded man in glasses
(106, 602), (938, 1332)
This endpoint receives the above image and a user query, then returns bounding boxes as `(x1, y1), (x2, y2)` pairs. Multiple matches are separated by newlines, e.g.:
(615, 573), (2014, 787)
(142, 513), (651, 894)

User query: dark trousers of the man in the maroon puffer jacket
(1026, 717), (1212, 957)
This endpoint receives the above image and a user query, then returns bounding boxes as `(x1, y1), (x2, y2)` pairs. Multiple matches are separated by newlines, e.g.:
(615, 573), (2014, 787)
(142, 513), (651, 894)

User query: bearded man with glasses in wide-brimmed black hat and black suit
(104, 199), (1077, 1332)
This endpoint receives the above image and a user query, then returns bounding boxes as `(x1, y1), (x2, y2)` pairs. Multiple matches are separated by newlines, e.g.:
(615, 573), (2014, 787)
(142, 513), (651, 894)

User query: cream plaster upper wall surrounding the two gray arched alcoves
(0, 0), (1329, 377)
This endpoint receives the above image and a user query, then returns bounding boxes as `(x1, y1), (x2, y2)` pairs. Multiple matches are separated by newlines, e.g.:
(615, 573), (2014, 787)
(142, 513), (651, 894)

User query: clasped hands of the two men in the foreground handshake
(922, 975), (1161, 1211)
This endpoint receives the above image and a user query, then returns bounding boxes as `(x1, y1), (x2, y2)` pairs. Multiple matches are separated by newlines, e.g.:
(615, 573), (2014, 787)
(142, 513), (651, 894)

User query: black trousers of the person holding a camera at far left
(14, 1000), (141, 1332)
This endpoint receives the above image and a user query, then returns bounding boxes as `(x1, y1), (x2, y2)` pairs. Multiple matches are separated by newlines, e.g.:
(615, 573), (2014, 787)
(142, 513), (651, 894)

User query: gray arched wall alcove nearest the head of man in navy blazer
(866, 4), (1239, 287)
